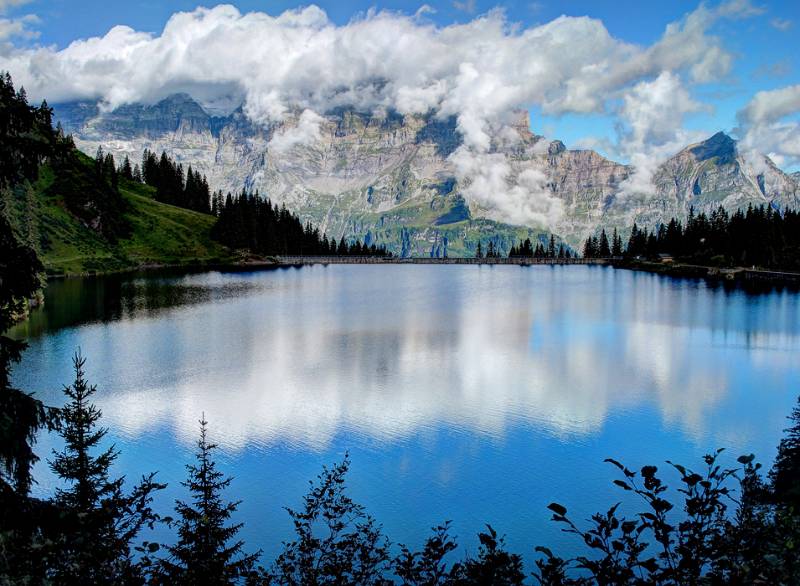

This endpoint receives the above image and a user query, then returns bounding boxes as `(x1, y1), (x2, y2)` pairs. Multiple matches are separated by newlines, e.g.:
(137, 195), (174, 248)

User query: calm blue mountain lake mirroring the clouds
(7, 265), (800, 571)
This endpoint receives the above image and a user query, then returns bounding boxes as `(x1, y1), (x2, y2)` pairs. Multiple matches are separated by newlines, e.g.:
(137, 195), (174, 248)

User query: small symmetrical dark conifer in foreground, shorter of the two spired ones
(158, 416), (260, 585)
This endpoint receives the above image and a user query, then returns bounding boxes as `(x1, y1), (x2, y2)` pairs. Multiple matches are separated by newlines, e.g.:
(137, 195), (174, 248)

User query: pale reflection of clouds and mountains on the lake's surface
(14, 266), (800, 453)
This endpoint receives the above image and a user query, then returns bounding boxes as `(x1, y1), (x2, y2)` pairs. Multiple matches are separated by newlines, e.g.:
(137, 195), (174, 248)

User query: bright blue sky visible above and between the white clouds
(0, 0), (800, 166)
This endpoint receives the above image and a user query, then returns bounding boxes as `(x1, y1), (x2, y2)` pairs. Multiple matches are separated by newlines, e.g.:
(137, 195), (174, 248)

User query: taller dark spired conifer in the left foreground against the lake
(50, 354), (165, 585)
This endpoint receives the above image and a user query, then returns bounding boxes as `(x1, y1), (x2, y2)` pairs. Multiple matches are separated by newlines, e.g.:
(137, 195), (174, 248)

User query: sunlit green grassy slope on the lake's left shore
(5, 158), (231, 274)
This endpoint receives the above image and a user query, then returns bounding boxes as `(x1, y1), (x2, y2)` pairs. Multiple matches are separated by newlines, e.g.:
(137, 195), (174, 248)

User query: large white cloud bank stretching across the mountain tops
(0, 0), (760, 217)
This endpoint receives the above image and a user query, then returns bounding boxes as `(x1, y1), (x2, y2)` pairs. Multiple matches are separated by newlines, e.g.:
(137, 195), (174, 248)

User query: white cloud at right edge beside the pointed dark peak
(737, 84), (800, 166)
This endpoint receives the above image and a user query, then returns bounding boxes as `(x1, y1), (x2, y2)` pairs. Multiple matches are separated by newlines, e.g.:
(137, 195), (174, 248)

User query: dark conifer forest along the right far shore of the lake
(583, 205), (800, 270)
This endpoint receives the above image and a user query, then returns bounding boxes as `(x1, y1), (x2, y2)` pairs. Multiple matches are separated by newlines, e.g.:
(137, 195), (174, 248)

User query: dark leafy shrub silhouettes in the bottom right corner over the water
(535, 450), (800, 585)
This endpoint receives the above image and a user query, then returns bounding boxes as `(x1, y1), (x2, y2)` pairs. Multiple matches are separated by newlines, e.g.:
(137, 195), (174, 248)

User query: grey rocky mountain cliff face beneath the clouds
(56, 95), (800, 255)
